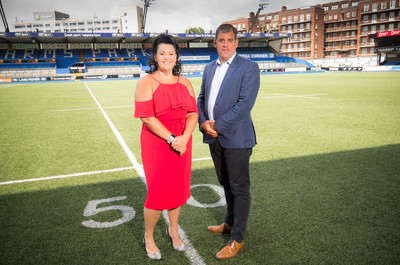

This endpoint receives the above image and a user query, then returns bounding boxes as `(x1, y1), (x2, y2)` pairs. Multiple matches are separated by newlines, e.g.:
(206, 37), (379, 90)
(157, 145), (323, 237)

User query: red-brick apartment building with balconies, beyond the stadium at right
(226, 0), (400, 59)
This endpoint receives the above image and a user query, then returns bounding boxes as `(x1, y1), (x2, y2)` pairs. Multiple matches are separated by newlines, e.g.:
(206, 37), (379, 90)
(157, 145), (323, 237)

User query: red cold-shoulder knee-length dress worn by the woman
(134, 77), (198, 210)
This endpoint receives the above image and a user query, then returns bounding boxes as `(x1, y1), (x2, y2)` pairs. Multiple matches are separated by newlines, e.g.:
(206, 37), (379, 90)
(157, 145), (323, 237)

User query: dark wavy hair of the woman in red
(146, 33), (182, 76)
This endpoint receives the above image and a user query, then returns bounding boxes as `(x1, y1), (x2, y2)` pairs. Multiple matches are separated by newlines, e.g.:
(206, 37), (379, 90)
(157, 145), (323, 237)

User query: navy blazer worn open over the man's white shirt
(197, 54), (260, 148)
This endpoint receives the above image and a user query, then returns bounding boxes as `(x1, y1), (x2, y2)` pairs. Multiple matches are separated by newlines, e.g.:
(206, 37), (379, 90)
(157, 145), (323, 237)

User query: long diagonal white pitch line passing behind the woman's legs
(84, 82), (205, 265)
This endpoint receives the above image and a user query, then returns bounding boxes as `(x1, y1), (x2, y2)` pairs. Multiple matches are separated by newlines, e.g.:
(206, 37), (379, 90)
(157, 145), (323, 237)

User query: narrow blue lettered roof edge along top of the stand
(0, 32), (291, 43)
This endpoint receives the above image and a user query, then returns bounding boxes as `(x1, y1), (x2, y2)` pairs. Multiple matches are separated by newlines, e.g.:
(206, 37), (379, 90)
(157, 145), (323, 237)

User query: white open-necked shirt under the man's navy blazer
(208, 53), (236, 120)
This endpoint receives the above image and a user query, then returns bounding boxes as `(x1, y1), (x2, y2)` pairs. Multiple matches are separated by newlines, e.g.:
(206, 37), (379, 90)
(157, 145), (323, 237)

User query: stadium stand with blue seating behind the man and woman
(0, 33), (322, 81)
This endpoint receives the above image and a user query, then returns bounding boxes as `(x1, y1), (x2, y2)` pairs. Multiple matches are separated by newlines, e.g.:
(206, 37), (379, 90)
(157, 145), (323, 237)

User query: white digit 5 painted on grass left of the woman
(82, 196), (136, 228)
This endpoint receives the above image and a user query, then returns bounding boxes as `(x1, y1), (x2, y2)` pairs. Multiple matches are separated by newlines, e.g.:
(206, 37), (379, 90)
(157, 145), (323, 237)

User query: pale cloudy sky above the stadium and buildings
(0, 0), (334, 33)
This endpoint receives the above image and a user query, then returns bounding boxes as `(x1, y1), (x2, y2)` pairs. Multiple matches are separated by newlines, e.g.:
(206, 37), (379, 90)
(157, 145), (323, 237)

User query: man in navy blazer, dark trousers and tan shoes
(197, 24), (260, 260)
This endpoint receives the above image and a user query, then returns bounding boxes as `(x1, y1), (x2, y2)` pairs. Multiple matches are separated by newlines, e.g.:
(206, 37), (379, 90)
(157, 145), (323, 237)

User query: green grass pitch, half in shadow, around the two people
(0, 73), (400, 264)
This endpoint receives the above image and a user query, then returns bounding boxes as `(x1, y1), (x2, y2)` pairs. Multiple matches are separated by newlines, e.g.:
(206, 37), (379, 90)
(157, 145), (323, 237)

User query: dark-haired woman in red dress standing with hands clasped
(134, 34), (198, 259)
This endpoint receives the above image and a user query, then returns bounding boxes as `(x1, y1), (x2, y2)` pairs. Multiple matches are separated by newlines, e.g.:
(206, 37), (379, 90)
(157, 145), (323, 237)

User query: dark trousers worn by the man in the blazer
(210, 140), (253, 242)
